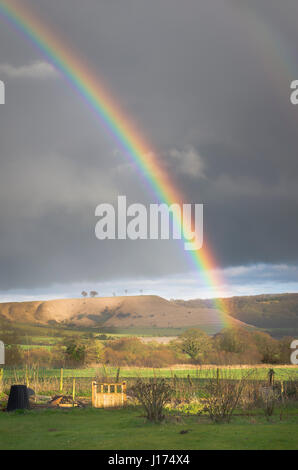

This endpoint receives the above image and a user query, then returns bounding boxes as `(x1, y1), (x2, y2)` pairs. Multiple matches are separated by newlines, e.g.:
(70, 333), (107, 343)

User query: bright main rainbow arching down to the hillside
(0, 0), (232, 327)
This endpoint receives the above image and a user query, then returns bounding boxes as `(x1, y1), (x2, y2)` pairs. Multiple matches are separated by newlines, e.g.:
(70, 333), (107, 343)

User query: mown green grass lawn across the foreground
(0, 408), (298, 450)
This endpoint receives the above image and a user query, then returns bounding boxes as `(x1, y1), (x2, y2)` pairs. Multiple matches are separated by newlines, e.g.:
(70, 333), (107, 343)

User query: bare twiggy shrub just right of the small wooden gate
(131, 379), (173, 422)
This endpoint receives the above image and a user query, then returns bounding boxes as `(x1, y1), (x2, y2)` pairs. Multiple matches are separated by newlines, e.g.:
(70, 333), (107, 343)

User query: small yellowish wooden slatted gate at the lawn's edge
(92, 381), (127, 408)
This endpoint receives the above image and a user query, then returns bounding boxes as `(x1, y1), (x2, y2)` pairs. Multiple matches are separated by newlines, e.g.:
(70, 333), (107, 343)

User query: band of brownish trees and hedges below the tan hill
(0, 321), (293, 367)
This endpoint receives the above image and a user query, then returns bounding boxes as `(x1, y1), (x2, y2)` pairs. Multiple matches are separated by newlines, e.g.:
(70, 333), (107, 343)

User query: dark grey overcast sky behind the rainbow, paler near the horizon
(0, 0), (298, 300)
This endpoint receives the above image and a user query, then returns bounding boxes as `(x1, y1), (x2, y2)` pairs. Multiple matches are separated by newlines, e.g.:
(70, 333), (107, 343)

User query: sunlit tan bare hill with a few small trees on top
(0, 295), (247, 334)
